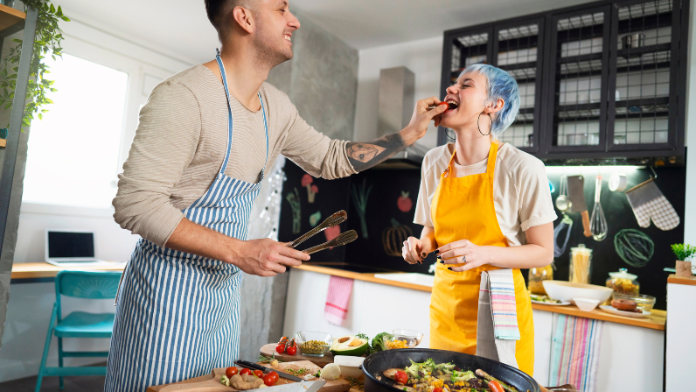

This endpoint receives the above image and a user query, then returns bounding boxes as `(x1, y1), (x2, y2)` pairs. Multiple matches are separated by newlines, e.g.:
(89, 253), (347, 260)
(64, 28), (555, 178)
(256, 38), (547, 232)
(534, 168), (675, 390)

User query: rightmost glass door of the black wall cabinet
(608, 0), (686, 150)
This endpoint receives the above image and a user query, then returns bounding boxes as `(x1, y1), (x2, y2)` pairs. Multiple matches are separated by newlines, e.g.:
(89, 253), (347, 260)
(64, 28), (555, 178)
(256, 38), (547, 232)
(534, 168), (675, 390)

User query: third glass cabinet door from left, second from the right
(544, 6), (610, 153)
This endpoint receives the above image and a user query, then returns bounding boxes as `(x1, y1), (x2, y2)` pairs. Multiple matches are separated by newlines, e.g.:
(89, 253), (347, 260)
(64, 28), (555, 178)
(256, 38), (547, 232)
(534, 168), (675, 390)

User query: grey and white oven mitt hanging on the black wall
(626, 179), (679, 231)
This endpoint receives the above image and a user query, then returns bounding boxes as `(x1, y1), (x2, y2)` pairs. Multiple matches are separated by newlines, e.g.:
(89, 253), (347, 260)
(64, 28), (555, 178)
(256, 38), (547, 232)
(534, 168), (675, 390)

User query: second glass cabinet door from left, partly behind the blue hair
(493, 18), (544, 152)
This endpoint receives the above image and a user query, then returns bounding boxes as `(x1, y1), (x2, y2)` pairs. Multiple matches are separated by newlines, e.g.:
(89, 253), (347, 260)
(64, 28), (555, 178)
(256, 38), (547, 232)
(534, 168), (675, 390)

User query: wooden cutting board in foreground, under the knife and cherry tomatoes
(147, 361), (350, 392)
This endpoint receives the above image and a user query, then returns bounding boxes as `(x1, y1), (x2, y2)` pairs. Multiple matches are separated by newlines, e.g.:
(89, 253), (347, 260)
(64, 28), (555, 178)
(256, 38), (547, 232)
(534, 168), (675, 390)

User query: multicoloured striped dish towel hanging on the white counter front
(548, 314), (604, 392)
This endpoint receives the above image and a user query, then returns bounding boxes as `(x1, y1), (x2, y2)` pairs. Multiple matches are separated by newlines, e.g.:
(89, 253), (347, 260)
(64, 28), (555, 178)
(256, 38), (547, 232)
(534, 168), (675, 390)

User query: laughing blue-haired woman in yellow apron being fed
(402, 64), (556, 375)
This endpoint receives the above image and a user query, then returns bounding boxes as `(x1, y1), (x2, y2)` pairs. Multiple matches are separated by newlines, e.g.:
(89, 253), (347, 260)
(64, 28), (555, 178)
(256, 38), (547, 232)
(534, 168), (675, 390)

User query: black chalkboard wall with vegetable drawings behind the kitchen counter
(279, 161), (686, 309)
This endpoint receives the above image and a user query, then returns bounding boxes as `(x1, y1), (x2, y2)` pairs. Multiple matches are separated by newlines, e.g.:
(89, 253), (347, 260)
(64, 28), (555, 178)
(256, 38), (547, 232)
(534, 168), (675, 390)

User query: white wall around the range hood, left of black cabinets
(353, 36), (442, 149)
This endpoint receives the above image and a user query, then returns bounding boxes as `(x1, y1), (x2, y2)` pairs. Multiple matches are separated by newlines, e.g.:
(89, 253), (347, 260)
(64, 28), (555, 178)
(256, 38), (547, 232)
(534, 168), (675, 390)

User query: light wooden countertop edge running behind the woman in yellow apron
(293, 262), (664, 331)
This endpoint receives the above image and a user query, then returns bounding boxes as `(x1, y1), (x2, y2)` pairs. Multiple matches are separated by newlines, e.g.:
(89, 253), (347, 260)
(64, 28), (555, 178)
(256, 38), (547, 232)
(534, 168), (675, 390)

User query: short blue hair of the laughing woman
(459, 64), (520, 138)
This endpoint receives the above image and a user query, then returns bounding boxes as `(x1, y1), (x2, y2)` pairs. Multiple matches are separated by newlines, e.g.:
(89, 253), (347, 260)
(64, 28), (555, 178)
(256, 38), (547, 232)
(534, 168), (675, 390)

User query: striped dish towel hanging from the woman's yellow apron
(487, 268), (520, 340)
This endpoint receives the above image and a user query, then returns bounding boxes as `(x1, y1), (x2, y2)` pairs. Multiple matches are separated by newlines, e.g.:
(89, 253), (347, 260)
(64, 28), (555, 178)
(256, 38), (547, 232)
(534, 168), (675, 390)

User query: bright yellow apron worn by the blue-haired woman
(430, 143), (534, 375)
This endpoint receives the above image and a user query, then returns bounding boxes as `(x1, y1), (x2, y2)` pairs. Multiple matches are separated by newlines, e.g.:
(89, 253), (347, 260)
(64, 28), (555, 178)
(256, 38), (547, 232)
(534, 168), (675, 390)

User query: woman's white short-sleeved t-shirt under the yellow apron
(413, 143), (557, 246)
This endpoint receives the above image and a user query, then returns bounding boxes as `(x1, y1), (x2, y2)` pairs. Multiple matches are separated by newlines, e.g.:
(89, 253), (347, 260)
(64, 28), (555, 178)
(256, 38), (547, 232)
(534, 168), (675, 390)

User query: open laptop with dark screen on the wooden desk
(45, 230), (115, 268)
